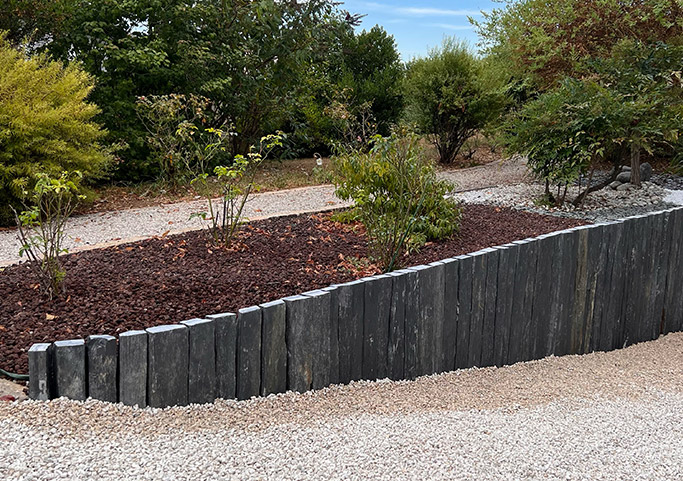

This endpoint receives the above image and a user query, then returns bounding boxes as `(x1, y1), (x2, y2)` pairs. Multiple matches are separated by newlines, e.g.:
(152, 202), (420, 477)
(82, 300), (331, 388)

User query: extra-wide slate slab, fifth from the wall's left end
(147, 324), (190, 408)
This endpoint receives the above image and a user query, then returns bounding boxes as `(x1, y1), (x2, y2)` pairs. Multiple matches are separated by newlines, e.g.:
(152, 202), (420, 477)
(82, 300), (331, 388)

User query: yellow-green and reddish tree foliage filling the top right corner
(473, 0), (683, 90)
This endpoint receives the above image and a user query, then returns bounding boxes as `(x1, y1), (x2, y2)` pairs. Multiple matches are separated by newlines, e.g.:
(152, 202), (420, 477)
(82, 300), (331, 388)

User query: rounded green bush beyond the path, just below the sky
(405, 39), (504, 164)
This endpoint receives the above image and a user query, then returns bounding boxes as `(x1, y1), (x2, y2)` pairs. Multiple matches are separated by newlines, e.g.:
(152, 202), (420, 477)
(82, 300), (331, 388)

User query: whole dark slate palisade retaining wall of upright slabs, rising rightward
(28, 209), (683, 407)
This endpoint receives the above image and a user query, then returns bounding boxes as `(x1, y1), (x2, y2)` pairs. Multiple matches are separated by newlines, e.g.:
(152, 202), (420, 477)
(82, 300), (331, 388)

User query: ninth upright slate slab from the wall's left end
(260, 300), (287, 396)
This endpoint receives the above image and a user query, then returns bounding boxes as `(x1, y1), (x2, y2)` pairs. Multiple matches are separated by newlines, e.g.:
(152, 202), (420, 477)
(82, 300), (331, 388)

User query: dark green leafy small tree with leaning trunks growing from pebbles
(506, 41), (683, 205)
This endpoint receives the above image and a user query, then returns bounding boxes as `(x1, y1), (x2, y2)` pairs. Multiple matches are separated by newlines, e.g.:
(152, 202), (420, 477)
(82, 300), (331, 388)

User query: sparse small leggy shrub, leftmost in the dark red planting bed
(15, 172), (81, 299)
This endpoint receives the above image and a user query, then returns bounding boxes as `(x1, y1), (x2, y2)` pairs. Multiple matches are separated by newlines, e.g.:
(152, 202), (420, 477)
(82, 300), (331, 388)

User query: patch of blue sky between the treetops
(341, 0), (502, 60)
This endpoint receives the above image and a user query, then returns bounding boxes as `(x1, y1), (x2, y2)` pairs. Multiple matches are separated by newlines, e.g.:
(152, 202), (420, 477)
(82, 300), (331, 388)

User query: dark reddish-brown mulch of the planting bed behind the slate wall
(0, 205), (584, 373)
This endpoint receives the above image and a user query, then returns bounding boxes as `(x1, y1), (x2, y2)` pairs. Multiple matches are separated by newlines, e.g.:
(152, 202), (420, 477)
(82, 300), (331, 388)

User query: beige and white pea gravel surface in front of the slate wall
(0, 334), (683, 480)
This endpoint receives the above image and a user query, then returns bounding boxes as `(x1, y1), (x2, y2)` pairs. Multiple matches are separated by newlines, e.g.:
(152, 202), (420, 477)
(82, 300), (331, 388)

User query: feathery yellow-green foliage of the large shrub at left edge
(0, 34), (109, 223)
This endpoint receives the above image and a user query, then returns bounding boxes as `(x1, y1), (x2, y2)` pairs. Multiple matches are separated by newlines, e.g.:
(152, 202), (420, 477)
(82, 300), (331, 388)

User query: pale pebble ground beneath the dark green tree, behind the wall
(455, 182), (683, 222)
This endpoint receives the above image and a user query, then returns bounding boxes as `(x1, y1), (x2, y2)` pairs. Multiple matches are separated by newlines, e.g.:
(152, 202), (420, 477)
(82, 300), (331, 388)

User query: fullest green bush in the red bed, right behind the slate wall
(334, 128), (460, 271)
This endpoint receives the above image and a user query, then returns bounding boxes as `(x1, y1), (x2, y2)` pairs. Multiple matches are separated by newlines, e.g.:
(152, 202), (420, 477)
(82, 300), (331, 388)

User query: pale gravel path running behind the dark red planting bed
(0, 159), (526, 266)
